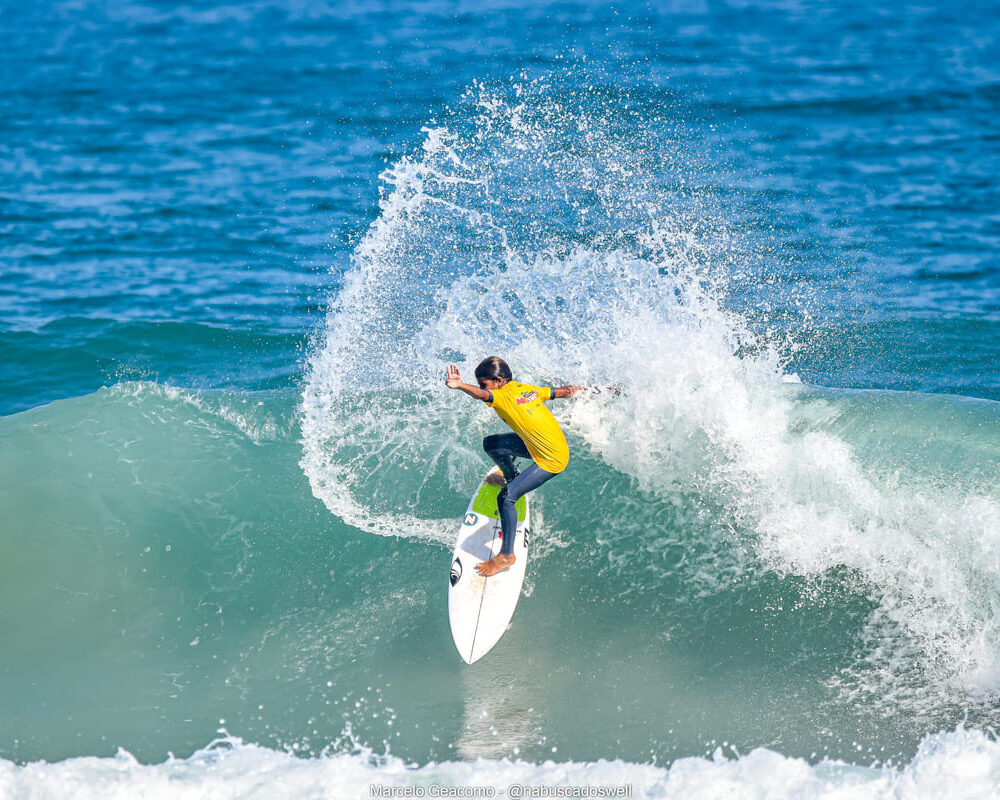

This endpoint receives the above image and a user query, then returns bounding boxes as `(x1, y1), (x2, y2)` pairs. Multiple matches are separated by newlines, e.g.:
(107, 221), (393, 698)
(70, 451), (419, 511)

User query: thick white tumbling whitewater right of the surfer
(570, 302), (1000, 705)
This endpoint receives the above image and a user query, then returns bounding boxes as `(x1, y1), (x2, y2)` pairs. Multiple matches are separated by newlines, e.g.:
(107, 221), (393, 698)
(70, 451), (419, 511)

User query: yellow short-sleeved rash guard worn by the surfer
(486, 381), (569, 473)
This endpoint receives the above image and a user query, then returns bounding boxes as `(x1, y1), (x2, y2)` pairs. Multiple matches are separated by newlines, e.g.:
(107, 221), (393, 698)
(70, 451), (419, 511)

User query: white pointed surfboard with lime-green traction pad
(448, 469), (529, 664)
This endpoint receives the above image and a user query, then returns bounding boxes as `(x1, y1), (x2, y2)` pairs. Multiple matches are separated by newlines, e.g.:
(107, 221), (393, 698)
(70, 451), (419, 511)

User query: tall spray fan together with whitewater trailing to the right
(301, 79), (1000, 713)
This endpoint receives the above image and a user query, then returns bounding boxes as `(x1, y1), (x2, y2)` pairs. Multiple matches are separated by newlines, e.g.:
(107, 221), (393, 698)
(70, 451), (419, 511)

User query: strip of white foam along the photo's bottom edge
(0, 728), (1000, 800)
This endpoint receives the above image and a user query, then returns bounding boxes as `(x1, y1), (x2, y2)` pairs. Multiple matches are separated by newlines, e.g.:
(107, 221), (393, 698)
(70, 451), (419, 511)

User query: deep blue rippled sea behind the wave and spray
(0, 1), (1000, 413)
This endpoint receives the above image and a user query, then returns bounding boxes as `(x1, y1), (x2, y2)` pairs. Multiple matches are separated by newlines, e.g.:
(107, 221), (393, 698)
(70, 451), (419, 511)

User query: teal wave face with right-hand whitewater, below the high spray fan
(0, 384), (1000, 762)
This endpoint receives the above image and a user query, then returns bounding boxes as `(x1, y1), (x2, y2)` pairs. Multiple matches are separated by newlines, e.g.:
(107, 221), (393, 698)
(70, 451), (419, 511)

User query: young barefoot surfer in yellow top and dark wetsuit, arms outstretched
(445, 356), (584, 576)
